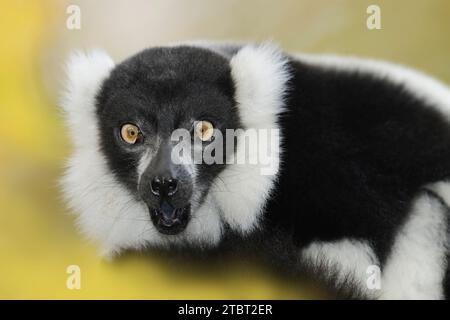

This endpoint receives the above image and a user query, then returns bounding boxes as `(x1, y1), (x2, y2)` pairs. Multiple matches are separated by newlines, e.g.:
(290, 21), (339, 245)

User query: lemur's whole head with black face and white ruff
(63, 44), (287, 254)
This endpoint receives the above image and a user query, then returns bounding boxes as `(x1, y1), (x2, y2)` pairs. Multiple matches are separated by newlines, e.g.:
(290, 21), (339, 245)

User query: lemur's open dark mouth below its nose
(149, 202), (191, 235)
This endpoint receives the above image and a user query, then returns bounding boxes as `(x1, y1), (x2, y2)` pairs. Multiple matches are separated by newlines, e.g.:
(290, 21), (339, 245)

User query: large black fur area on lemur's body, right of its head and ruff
(264, 60), (450, 298)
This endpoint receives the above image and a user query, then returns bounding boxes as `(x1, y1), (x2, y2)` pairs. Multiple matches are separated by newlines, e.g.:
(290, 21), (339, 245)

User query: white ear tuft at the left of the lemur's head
(61, 50), (114, 146)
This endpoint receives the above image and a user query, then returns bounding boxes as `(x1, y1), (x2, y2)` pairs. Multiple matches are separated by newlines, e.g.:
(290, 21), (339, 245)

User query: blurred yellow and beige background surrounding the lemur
(0, 0), (450, 299)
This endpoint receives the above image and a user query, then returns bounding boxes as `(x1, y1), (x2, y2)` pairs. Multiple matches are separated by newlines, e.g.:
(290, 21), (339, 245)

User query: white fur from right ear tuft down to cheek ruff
(214, 43), (290, 234)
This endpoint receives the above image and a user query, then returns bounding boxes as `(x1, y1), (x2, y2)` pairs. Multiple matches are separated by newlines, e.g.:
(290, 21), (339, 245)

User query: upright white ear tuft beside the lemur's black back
(230, 42), (290, 128)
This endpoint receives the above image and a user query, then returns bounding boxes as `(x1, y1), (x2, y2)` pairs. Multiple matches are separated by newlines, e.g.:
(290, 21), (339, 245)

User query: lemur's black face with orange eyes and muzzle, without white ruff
(96, 47), (240, 235)
